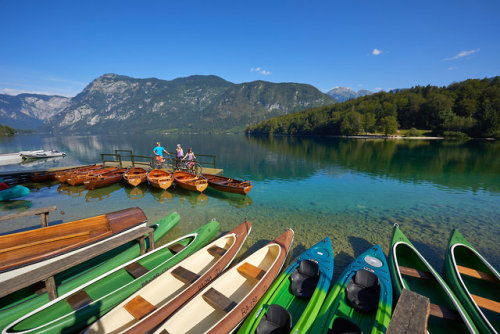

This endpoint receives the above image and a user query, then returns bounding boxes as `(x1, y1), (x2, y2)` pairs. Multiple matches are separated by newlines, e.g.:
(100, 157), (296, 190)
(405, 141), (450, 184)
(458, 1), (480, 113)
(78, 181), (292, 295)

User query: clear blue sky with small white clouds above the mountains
(0, 0), (500, 96)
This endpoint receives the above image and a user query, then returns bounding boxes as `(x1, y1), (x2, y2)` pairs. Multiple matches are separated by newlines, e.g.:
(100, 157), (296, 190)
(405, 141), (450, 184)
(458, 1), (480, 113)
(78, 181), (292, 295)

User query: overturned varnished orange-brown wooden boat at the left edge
(0, 208), (146, 276)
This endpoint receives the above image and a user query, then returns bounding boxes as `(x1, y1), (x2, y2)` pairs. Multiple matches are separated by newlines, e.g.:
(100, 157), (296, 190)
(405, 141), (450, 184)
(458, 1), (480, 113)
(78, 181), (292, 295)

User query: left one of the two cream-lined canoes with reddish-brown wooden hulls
(86, 221), (251, 334)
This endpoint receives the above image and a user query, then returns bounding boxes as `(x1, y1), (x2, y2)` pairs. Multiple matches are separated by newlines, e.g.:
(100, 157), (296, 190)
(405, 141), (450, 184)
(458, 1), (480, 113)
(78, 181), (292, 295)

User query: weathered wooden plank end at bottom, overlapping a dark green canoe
(387, 289), (430, 334)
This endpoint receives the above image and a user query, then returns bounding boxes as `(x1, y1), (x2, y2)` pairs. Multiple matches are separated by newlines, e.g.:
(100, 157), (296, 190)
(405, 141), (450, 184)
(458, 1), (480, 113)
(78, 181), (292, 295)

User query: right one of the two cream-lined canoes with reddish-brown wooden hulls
(155, 229), (293, 333)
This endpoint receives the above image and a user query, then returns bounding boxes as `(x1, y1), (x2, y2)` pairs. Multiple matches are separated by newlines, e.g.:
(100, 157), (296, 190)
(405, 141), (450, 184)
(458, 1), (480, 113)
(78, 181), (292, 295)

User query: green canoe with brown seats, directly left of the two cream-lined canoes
(3, 221), (219, 333)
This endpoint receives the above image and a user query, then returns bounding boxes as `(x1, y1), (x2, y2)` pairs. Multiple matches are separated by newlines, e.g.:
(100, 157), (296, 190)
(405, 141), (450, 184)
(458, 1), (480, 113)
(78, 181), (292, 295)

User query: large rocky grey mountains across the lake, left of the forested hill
(0, 74), (336, 133)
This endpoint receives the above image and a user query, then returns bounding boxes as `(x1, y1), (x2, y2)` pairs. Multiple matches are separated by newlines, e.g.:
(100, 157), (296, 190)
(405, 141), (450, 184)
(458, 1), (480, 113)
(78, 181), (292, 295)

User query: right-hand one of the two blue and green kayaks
(310, 245), (392, 333)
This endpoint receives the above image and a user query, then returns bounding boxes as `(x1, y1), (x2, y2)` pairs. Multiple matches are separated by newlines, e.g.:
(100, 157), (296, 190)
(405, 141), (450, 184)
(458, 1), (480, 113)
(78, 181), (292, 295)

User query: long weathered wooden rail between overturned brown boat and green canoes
(0, 227), (153, 298)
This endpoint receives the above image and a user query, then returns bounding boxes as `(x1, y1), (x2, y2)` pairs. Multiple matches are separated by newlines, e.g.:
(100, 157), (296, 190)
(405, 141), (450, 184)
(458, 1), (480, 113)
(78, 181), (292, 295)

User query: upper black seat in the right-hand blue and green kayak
(346, 269), (380, 313)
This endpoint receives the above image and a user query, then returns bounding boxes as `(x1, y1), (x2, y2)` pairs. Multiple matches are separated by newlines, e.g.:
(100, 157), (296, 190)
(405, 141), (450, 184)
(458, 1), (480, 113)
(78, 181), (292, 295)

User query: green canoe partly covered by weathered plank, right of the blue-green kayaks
(389, 225), (478, 334)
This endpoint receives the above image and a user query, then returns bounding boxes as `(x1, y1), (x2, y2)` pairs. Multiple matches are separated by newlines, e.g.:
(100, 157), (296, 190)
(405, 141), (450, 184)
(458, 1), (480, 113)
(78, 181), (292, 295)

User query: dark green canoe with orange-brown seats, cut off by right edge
(444, 229), (500, 333)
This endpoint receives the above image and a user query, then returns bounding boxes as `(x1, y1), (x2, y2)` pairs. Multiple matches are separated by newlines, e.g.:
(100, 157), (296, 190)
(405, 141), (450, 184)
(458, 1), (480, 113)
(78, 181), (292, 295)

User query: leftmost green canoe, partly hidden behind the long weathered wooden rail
(0, 212), (180, 331)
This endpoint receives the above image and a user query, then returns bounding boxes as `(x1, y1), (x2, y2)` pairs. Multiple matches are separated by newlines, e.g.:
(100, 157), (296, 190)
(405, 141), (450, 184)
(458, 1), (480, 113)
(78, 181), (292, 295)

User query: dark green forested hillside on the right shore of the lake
(247, 76), (500, 137)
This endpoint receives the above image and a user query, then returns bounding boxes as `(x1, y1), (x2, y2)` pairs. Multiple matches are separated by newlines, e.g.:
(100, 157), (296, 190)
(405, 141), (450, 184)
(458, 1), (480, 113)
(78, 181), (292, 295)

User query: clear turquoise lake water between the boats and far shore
(0, 135), (500, 274)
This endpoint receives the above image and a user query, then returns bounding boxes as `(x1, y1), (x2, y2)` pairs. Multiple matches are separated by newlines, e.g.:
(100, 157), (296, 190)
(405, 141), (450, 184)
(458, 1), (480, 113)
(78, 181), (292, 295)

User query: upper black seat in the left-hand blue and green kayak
(290, 260), (319, 299)
